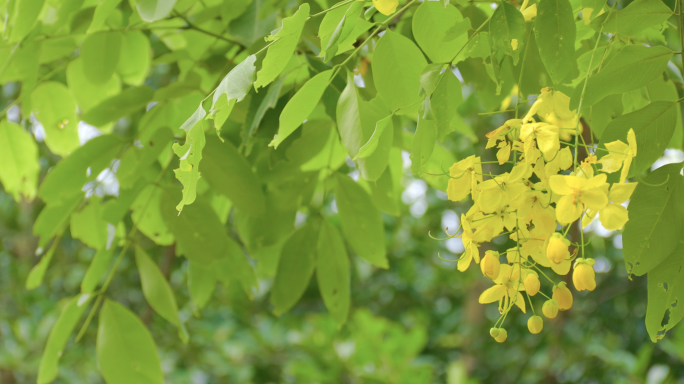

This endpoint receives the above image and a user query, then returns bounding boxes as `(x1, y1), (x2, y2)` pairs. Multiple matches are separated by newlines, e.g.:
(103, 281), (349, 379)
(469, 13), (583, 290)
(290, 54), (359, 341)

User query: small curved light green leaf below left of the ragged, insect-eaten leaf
(131, 184), (174, 245)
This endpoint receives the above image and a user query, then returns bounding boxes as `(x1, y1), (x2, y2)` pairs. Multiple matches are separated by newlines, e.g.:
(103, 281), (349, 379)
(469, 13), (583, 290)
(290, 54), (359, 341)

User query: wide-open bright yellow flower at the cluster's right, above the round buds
(549, 174), (608, 225)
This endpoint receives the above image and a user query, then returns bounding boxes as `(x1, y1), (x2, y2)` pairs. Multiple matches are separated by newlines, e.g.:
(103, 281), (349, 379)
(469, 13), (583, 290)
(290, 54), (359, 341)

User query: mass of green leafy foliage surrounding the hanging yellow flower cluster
(0, 0), (684, 383)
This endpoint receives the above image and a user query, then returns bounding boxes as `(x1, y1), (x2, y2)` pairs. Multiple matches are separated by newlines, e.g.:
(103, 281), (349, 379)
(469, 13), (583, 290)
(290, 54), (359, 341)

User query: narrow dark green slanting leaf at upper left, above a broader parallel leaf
(83, 85), (154, 127)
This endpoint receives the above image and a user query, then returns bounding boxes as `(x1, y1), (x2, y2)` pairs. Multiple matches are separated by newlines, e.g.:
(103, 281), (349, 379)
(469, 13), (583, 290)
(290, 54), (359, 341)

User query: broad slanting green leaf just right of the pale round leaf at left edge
(38, 135), (124, 205)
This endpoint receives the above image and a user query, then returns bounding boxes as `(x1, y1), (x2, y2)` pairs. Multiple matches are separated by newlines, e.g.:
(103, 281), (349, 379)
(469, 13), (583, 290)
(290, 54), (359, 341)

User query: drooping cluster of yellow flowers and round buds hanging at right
(440, 88), (637, 342)
